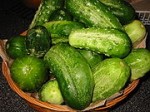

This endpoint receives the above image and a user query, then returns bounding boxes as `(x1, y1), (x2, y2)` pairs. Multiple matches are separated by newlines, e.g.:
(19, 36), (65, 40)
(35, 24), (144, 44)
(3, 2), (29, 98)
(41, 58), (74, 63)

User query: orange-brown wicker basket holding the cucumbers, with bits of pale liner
(0, 32), (146, 112)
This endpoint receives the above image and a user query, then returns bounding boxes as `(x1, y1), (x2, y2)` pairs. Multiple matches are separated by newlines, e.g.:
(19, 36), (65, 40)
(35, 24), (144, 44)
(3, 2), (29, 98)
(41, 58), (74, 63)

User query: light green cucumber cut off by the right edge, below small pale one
(124, 48), (150, 81)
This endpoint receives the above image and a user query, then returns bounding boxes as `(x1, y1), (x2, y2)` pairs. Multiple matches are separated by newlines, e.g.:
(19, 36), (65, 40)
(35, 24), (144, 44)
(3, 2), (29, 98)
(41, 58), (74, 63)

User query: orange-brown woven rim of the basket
(2, 60), (140, 112)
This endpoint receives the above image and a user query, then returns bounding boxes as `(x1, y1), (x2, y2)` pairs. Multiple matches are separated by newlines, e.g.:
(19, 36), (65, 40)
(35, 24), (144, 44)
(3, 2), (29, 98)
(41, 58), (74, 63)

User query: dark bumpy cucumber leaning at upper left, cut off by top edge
(29, 0), (64, 29)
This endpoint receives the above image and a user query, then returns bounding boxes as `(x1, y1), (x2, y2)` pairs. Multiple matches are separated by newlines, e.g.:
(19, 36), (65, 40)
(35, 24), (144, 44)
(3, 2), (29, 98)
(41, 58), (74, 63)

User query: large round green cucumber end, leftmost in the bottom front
(10, 56), (48, 92)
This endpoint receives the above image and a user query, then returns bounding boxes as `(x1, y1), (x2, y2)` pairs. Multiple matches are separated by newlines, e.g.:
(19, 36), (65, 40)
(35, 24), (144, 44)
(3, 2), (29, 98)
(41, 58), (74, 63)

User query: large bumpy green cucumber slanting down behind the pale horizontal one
(66, 0), (122, 29)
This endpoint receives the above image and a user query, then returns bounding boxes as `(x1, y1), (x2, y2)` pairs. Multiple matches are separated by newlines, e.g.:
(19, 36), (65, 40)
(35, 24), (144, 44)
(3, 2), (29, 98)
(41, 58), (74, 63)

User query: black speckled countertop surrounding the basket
(0, 0), (150, 112)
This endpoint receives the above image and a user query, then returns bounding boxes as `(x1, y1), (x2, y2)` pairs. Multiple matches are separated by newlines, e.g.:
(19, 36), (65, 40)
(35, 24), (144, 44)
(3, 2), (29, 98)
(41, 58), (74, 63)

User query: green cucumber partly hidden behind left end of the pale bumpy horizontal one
(43, 20), (84, 44)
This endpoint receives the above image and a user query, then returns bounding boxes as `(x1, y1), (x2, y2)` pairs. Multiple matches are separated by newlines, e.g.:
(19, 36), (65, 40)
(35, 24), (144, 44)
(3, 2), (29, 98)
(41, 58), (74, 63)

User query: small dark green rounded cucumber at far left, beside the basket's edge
(6, 35), (27, 59)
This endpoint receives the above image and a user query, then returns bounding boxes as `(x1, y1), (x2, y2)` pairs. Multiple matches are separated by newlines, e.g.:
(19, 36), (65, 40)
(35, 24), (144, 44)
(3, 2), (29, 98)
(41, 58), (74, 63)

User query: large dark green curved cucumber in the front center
(44, 43), (94, 109)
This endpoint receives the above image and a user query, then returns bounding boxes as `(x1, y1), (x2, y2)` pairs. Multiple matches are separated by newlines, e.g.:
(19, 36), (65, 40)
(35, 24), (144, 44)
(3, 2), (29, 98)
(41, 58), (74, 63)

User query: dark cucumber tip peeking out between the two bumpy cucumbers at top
(49, 8), (73, 21)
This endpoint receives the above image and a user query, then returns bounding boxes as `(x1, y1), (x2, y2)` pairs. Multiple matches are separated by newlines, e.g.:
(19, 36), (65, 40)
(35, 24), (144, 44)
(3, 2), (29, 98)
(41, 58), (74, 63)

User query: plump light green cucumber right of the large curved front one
(93, 58), (130, 102)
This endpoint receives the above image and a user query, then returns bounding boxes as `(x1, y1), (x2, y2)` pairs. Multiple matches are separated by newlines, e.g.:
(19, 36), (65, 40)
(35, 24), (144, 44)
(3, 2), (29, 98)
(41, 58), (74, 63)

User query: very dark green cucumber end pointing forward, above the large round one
(26, 26), (51, 57)
